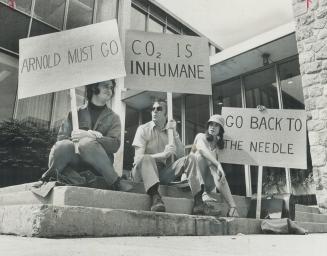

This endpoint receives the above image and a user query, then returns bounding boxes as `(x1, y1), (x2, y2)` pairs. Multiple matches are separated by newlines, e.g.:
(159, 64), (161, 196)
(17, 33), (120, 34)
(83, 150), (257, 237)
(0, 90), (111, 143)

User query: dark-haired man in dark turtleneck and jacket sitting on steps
(41, 80), (132, 191)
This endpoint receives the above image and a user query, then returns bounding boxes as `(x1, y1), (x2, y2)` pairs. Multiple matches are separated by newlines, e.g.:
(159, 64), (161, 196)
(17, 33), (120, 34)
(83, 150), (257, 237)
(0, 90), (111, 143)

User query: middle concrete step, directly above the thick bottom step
(0, 186), (248, 217)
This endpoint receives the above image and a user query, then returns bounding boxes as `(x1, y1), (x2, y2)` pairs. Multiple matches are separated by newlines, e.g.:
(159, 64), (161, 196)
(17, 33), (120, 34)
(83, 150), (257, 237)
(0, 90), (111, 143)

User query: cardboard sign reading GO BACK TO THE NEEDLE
(219, 108), (307, 169)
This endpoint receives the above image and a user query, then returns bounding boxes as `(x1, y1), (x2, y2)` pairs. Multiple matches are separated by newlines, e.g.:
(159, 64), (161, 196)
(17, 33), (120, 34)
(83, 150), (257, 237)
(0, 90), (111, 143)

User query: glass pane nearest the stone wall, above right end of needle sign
(278, 58), (304, 109)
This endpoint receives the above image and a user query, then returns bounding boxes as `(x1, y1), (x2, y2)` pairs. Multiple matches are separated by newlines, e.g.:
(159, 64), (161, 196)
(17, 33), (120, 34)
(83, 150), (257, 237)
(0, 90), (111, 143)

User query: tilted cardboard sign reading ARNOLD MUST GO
(18, 20), (126, 99)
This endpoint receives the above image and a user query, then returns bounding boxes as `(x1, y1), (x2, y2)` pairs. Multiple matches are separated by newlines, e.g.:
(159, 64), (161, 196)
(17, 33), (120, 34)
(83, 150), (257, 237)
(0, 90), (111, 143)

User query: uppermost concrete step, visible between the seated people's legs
(0, 180), (251, 208)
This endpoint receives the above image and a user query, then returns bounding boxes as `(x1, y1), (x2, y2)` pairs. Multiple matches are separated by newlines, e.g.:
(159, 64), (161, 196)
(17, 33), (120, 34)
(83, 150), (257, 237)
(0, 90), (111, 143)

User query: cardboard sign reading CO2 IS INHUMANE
(125, 31), (212, 95)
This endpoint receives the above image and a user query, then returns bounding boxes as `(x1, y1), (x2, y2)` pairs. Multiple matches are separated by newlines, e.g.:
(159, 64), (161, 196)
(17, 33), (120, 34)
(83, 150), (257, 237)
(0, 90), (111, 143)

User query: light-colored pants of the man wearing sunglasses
(132, 155), (203, 195)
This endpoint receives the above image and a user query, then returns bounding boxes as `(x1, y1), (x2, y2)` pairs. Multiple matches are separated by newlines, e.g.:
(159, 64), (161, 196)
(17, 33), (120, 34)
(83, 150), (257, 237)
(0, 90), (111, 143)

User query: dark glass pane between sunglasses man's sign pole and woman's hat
(185, 95), (209, 145)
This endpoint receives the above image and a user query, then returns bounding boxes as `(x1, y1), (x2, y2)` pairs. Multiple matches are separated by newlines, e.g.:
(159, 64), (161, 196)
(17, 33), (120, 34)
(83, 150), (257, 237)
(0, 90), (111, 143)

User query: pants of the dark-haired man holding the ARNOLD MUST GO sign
(47, 138), (118, 186)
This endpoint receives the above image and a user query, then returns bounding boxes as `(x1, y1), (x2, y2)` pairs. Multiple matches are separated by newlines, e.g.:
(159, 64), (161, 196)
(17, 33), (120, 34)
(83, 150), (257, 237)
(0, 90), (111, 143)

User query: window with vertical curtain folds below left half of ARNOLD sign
(16, 93), (53, 128)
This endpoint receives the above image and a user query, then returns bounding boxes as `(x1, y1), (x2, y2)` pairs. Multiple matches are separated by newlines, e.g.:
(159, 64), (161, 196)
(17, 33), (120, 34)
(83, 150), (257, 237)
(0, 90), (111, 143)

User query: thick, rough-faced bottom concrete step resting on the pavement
(0, 205), (261, 238)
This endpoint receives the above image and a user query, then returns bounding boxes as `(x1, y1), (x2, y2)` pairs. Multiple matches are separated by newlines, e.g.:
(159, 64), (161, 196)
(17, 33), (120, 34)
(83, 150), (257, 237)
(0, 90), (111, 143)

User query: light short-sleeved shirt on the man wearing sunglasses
(132, 121), (168, 163)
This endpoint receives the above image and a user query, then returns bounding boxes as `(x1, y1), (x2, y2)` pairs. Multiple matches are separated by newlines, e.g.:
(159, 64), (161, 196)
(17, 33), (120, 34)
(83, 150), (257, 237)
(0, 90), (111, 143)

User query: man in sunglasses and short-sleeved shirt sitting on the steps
(132, 100), (217, 215)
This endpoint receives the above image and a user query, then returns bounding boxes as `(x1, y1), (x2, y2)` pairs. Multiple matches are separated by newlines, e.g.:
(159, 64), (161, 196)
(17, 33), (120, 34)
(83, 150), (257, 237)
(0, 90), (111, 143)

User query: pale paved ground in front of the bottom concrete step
(0, 234), (327, 256)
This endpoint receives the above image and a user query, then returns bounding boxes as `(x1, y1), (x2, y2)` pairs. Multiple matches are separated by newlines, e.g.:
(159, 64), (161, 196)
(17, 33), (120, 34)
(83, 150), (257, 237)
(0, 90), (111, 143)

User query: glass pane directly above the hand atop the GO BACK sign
(244, 68), (278, 108)
